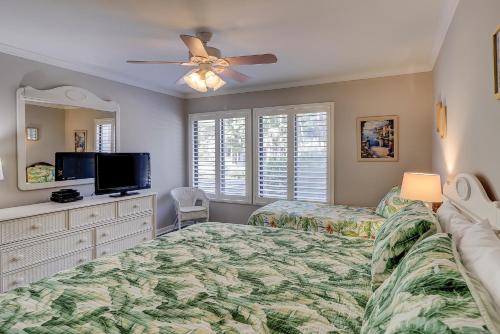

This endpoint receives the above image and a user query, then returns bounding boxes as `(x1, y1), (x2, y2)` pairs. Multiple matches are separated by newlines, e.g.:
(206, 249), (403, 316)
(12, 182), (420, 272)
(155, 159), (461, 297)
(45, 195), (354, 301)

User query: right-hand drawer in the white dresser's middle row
(96, 215), (153, 244)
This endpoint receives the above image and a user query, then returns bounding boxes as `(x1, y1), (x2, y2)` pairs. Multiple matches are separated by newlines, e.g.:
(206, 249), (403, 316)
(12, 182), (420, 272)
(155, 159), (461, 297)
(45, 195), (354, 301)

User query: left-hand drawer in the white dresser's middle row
(1, 231), (93, 273)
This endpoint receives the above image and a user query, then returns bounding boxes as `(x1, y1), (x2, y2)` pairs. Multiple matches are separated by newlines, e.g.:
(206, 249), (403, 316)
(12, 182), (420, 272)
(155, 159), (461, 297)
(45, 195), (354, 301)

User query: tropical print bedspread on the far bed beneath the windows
(248, 201), (385, 239)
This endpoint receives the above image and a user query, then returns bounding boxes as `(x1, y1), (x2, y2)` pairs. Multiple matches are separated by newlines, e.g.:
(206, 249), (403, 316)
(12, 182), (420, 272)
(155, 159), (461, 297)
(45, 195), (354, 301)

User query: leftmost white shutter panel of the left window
(192, 119), (216, 195)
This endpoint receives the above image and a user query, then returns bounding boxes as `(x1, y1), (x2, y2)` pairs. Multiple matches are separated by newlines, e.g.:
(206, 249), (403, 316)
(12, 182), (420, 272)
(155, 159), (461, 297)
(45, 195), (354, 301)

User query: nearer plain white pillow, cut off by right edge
(458, 221), (500, 308)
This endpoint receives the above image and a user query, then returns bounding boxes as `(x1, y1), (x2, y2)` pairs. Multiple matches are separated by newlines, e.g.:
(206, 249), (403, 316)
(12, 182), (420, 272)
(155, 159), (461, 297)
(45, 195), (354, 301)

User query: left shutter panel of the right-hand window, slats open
(257, 114), (288, 199)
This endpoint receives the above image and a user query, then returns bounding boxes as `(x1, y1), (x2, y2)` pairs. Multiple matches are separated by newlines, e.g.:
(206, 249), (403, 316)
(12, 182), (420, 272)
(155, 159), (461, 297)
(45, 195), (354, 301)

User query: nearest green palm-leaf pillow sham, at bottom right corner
(361, 233), (499, 334)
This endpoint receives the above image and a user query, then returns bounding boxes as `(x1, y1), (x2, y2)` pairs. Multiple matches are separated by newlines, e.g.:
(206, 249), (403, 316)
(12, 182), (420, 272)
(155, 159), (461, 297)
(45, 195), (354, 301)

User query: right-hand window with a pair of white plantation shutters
(254, 103), (332, 204)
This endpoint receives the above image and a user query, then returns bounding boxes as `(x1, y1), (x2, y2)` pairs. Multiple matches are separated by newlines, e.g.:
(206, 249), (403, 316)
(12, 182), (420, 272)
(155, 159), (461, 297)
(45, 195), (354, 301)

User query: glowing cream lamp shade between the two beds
(400, 173), (443, 203)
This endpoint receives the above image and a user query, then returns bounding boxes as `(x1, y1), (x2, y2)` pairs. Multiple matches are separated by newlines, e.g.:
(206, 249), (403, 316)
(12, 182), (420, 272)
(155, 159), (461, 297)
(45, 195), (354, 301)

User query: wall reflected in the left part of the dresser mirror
(26, 104), (65, 167)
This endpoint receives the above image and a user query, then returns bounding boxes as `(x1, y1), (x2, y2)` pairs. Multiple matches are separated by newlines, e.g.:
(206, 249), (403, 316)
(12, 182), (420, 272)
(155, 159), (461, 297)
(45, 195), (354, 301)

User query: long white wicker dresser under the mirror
(0, 193), (156, 292)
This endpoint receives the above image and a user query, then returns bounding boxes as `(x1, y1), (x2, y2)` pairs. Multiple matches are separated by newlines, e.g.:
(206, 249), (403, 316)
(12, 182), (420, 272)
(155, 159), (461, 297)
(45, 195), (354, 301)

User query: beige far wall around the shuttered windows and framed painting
(186, 73), (433, 223)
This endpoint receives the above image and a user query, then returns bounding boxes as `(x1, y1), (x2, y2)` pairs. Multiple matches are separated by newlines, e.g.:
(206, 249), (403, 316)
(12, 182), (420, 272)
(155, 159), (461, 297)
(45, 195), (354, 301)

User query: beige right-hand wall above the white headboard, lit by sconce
(433, 0), (500, 199)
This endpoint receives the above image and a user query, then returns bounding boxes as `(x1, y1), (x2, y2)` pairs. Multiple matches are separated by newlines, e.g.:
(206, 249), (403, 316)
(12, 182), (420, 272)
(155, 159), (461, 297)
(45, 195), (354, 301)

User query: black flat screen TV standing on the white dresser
(94, 153), (151, 197)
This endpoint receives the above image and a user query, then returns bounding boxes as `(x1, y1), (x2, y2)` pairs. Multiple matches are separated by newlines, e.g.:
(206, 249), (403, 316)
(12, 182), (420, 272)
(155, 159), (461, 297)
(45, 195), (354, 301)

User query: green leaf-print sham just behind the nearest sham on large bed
(371, 202), (441, 290)
